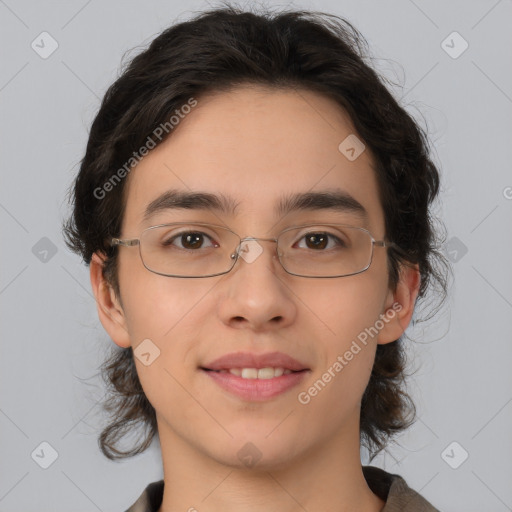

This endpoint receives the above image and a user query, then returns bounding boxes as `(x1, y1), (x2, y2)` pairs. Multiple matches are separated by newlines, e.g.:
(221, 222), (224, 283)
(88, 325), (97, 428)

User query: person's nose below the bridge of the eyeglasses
(218, 237), (297, 331)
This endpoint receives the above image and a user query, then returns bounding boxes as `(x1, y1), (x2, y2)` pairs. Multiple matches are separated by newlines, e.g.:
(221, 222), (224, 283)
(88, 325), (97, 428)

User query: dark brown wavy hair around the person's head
(63, 5), (447, 460)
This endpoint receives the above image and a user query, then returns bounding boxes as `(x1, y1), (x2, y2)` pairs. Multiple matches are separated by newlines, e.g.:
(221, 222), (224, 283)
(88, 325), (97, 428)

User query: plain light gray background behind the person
(0, 0), (512, 512)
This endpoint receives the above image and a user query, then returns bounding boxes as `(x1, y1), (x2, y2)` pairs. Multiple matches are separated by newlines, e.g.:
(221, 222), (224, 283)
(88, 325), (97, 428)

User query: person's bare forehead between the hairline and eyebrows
(123, 86), (383, 232)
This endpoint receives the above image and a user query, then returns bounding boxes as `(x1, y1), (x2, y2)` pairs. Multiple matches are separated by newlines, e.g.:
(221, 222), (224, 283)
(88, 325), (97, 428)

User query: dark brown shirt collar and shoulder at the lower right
(363, 466), (440, 512)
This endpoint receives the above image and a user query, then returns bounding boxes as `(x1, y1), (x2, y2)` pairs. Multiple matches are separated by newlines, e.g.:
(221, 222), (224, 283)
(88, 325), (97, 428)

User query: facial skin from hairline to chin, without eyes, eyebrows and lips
(96, 87), (410, 467)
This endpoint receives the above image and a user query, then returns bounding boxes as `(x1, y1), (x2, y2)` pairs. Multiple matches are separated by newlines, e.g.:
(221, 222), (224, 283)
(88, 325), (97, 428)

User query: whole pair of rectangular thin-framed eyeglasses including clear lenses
(111, 222), (394, 277)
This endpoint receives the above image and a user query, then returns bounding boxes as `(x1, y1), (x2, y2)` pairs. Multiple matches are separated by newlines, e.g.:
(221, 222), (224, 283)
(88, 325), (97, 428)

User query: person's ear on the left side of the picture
(90, 253), (131, 348)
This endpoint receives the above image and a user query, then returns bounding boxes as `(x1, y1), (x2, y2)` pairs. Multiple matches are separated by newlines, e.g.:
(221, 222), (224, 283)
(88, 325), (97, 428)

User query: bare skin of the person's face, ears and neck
(91, 86), (419, 512)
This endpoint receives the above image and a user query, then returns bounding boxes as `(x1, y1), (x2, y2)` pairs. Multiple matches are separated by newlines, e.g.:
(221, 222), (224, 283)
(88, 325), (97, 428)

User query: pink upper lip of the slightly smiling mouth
(201, 352), (309, 372)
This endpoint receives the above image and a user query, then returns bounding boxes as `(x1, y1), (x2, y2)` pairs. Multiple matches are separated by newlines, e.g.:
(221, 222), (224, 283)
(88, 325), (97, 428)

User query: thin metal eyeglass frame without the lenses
(110, 222), (396, 279)
